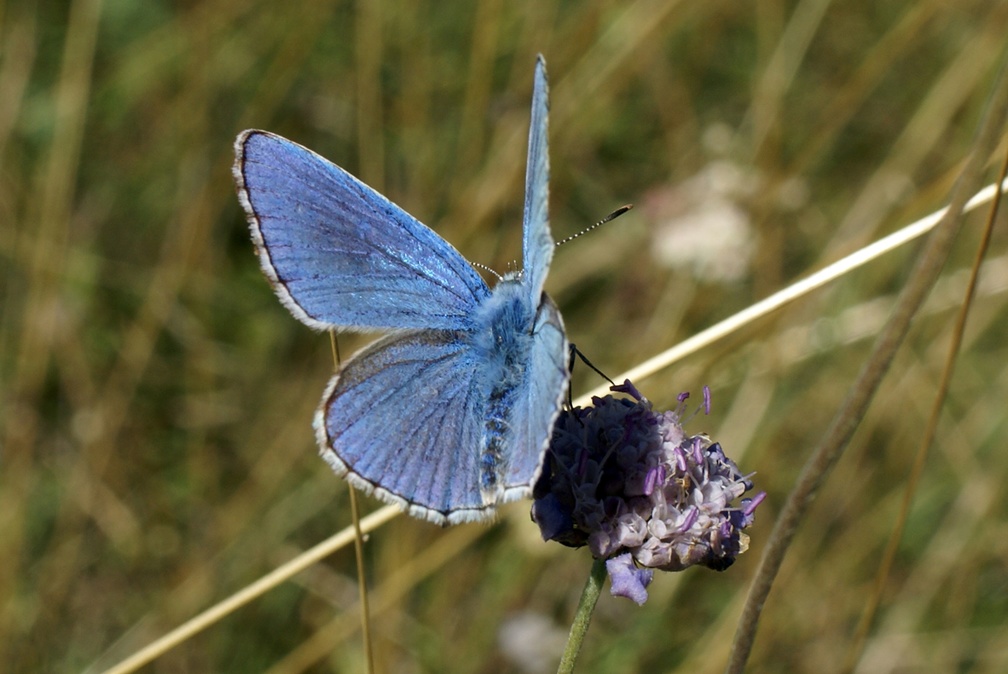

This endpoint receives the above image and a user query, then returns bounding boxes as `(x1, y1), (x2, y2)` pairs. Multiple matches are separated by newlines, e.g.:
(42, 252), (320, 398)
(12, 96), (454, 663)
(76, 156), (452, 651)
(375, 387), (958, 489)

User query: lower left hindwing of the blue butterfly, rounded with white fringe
(314, 330), (494, 524)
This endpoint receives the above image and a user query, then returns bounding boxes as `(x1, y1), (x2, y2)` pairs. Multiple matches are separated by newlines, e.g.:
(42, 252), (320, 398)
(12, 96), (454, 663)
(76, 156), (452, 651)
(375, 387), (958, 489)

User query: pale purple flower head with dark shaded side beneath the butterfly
(532, 381), (766, 603)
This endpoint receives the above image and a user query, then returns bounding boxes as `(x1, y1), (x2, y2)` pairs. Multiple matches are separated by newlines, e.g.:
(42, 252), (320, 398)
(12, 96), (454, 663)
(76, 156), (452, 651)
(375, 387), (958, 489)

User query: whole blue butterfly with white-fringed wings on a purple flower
(234, 56), (570, 524)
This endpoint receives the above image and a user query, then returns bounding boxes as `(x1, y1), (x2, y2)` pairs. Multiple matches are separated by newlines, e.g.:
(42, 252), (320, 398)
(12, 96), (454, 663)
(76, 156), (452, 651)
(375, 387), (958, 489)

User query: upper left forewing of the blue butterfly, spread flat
(234, 130), (489, 329)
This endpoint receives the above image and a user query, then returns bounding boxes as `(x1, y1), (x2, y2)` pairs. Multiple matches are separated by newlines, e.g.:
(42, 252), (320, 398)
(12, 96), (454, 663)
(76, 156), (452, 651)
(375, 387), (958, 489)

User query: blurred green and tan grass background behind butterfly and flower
(0, 0), (1008, 673)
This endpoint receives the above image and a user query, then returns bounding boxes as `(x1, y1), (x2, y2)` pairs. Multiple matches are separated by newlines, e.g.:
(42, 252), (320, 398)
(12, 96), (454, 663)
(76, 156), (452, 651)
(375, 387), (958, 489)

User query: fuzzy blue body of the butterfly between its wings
(474, 275), (535, 505)
